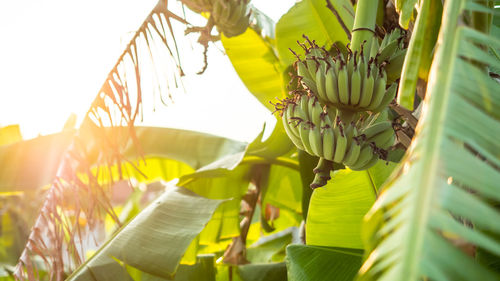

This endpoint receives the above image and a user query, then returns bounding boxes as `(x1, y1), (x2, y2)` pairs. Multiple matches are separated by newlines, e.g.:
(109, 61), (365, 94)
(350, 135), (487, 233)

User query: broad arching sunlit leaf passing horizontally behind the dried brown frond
(0, 127), (247, 191)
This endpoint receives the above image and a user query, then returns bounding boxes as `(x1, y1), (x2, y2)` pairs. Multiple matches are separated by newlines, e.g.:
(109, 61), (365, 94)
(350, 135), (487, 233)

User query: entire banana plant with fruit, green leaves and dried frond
(0, 0), (500, 280)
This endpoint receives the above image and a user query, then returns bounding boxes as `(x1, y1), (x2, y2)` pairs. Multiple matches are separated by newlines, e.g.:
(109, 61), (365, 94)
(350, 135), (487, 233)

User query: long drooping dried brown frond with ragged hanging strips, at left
(14, 0), (187, 280)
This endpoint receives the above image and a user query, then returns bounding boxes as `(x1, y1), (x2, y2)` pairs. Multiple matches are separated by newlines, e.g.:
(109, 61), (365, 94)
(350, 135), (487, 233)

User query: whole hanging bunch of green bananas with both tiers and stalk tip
(274, 30), (406, 184)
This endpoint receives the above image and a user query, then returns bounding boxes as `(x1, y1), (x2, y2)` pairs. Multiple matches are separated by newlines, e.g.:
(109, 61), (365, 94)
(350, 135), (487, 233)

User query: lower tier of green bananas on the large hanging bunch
(276, 94), (395, 170)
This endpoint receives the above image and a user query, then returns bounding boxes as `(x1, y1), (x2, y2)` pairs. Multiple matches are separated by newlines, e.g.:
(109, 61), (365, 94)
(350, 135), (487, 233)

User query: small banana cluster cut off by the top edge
(211, 0), (250, 37)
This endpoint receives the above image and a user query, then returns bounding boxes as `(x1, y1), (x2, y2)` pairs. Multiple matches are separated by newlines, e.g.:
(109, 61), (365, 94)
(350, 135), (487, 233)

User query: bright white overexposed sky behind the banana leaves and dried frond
(0, 0), (295, 141)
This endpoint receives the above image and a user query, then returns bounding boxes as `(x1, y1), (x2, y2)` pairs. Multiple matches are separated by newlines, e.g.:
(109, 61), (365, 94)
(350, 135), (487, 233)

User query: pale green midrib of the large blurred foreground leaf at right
(401, 0), (463, 280)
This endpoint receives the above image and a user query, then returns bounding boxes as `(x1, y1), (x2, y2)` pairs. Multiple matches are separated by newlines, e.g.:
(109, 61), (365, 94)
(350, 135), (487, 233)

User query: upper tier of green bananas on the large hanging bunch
(295, 37), (397, 112)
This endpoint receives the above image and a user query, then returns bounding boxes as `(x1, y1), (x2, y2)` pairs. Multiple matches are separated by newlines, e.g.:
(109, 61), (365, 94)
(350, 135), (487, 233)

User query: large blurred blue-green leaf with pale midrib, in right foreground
(358, 0), (500, 281)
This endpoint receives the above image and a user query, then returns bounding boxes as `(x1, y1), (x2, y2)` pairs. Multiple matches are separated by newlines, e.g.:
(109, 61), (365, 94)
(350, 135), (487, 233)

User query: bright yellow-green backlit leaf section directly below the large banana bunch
(306, 160), (395, 249)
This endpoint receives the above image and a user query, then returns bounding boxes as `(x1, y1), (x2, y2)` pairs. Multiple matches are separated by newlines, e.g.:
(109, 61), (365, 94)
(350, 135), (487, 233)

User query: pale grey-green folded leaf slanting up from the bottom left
(66, 187), (223, 281)
